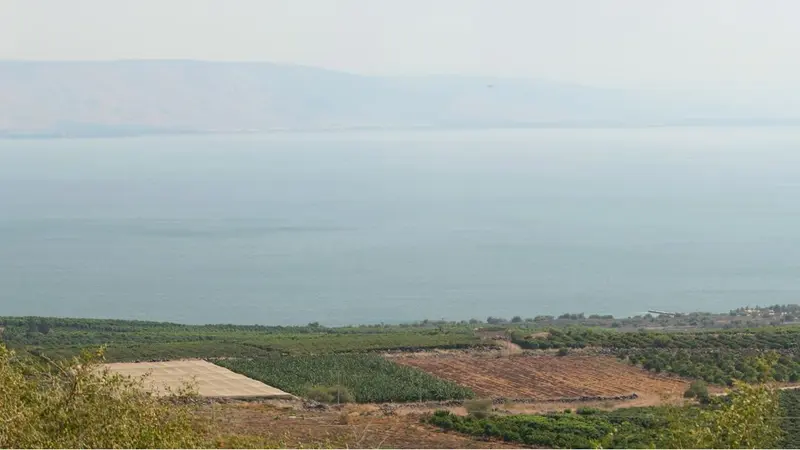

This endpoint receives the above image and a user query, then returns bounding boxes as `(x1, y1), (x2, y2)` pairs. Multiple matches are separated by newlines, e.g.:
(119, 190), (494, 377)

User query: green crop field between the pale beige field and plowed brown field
(216, 354), (474, 403)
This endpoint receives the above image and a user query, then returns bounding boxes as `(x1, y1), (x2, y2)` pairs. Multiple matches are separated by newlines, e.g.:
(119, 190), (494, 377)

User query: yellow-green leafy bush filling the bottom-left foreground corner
(0, 344), (205, 448)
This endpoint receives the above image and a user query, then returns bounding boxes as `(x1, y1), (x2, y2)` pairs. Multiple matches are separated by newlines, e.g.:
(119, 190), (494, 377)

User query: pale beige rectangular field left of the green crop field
(106, 360), (294, 399)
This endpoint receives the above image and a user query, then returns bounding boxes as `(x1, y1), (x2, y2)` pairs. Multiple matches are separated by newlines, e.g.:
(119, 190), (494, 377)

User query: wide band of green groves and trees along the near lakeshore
(0, 305), (800, 382)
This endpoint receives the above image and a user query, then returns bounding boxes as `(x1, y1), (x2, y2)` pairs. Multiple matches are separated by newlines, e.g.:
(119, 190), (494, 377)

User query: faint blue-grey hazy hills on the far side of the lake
(0, 60), (800, 137)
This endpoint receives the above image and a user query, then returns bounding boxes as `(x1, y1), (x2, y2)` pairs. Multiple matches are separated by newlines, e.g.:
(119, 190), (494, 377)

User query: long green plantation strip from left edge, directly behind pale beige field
(0, 317), (481, 361)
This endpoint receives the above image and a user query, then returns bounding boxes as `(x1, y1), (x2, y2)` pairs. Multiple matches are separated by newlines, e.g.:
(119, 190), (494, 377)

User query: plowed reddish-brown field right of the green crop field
(393, 355), (688, 401)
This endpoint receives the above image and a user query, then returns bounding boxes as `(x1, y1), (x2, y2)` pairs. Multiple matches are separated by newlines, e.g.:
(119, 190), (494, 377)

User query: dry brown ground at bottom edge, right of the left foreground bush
(204, 403), (519, 448)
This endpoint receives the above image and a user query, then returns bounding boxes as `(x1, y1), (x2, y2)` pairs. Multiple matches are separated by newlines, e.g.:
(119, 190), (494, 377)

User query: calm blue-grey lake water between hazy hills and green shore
(0, 128), (800, 325)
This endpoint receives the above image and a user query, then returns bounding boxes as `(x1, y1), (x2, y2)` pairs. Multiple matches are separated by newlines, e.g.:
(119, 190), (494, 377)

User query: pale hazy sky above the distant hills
(0, 0), (800, 88)
